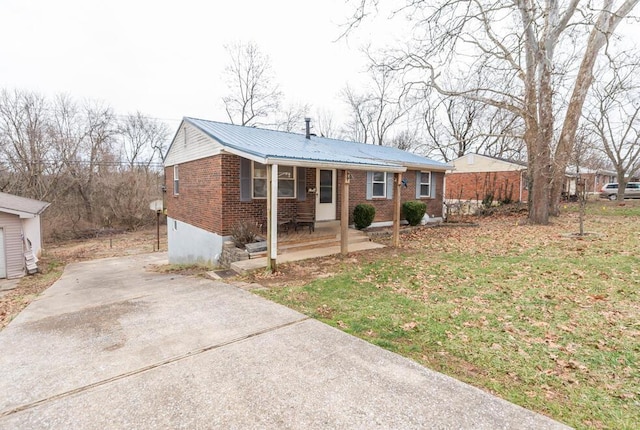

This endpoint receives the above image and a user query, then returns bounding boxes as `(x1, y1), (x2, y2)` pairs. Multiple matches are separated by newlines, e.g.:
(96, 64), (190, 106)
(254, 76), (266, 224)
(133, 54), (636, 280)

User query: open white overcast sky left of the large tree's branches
(0, 0), (400, 130)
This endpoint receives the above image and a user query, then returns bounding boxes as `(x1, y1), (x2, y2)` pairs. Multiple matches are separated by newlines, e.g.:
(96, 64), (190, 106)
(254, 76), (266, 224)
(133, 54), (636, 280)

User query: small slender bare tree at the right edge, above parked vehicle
(585, 62), (640, 200)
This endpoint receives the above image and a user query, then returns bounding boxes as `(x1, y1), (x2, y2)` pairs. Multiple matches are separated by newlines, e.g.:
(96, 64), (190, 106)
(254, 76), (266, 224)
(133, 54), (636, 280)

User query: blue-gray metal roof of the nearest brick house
(184, 118), (452, 171)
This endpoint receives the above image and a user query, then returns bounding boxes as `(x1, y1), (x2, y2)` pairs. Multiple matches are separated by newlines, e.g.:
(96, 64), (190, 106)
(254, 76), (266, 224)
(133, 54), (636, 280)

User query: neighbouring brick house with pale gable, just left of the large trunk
(445, 154), (529, 202)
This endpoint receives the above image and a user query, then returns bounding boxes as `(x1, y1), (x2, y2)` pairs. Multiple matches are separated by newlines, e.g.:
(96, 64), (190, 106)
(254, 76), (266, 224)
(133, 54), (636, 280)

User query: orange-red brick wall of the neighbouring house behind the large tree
(446, 171), (528, 202)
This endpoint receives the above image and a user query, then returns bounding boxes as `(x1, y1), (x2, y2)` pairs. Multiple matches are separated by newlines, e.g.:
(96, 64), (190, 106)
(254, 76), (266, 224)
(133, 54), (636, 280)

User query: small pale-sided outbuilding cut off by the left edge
(0, 193), (49, 278)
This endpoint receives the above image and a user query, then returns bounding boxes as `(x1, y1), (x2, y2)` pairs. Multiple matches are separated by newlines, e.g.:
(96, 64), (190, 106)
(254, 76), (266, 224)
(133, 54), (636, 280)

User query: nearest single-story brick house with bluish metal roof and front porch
(164, 118), (451, 263)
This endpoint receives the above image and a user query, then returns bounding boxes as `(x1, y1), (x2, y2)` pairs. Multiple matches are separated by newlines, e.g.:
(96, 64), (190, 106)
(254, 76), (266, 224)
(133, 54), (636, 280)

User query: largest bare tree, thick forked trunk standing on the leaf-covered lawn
(351, 0), (640, 224)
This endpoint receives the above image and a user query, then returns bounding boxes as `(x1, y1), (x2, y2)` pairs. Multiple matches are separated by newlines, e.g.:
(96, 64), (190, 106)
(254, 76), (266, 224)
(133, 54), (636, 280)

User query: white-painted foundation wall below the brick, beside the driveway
(167, 217), (227, 265)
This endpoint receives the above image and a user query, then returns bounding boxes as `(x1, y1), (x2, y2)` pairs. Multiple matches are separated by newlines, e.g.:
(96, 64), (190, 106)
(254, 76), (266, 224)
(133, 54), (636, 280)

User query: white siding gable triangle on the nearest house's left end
(164, 122), (222, 166)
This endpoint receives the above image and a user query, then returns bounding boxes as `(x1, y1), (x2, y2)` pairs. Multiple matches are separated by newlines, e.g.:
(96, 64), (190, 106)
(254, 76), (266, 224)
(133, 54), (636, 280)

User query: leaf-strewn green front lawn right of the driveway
(256, 202), (640, 429)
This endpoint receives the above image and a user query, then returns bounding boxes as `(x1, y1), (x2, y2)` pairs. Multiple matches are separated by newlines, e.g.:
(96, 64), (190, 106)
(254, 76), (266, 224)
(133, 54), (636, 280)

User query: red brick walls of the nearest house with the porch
(165, 155), (444, 236)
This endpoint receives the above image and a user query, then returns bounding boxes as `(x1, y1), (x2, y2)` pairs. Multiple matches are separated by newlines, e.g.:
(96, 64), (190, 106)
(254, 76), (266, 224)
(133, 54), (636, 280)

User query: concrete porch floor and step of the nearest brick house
(231, 221), (384, 273)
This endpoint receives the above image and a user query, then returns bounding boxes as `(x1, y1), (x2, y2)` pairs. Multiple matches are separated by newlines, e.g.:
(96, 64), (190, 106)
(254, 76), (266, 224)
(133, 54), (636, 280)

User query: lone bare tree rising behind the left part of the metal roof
(222, 42), (282, 125)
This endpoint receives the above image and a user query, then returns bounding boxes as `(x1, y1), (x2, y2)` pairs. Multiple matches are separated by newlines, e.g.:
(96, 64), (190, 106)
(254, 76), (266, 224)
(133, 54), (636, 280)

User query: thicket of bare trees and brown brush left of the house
(0, 90), (166, 236)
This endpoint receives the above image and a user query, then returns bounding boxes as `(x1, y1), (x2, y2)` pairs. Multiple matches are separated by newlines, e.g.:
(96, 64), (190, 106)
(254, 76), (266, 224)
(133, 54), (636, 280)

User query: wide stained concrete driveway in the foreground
(0, 254), (566, 430)
